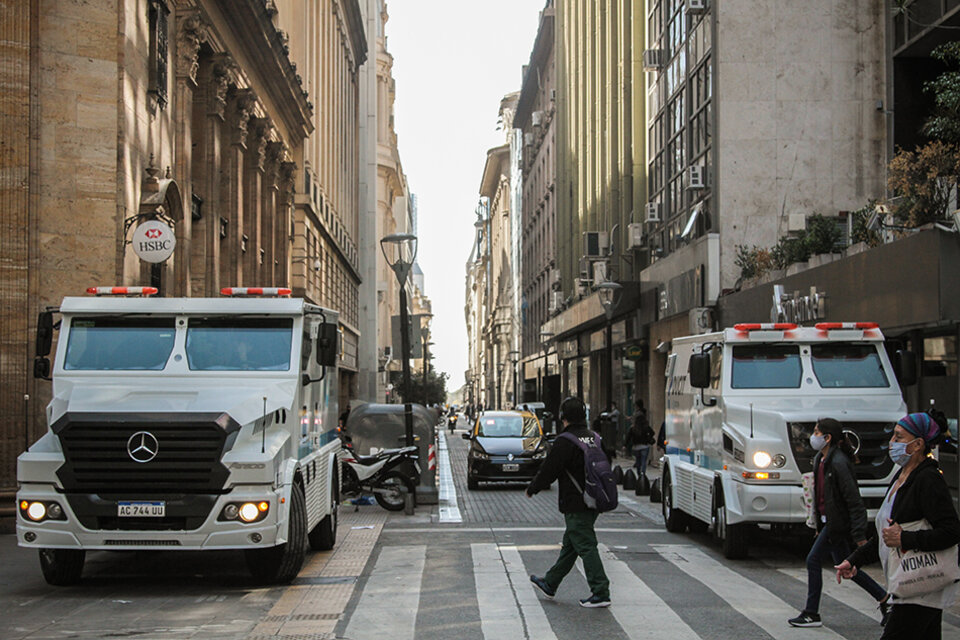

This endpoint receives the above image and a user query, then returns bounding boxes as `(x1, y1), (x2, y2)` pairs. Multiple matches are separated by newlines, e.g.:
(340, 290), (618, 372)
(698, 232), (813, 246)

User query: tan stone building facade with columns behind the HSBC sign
(0, 0), (314, 503)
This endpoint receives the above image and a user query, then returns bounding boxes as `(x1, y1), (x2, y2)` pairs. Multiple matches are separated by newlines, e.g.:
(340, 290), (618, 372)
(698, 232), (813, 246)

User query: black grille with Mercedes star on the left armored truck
(53, 414), (240, 497)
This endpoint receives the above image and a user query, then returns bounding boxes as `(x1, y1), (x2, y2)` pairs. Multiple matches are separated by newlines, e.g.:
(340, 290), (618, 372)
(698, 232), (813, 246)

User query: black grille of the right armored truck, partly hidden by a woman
(787, 422), (894, 480)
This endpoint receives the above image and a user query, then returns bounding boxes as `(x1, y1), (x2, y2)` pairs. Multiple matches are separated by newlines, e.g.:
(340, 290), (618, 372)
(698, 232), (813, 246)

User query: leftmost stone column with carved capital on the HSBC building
(171, 10), (204, 296)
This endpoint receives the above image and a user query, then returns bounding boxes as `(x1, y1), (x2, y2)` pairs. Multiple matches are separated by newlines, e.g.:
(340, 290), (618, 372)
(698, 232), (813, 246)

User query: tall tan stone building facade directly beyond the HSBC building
(278, 0), (367, 404)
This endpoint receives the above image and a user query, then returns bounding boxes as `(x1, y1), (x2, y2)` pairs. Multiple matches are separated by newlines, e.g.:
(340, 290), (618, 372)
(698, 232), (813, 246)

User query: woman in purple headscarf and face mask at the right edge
(836, 413), (960, 640)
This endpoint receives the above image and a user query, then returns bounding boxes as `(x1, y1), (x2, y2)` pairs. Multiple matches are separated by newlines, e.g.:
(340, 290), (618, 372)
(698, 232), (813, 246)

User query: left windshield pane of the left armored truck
(63, 316), (176, 371)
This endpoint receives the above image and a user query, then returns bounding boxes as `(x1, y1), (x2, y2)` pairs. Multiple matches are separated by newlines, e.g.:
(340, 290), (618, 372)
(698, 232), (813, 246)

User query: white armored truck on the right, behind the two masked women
(661, 322), (916, 558)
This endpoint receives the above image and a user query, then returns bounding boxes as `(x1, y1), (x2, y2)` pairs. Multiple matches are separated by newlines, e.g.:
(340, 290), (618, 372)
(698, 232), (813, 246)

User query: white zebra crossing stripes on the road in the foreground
(337, 542), (936, 640)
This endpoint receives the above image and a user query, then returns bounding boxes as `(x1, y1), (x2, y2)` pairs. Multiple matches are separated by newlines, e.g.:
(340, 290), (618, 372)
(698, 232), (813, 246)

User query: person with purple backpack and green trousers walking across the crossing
(526, 397), (610, 608)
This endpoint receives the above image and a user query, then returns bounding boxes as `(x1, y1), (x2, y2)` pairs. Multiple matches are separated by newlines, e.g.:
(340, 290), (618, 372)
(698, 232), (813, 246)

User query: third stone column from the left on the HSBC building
(220, 89), (255, 287)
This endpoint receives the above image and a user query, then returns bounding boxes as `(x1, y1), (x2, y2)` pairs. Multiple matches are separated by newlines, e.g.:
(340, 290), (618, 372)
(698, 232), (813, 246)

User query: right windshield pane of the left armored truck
(186, 317), (293, 371)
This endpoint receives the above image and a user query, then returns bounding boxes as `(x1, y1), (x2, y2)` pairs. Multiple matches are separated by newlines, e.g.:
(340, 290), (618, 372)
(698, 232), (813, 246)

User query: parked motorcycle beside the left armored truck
(340, 436), (420, 511)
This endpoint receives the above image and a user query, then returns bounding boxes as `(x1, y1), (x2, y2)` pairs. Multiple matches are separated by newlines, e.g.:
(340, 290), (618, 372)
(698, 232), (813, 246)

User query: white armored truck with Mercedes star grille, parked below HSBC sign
(17, 287), (340, 584)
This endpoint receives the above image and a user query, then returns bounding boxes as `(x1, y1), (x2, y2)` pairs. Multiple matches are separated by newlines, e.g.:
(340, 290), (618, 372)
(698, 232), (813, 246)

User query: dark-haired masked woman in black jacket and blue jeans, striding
(787, 418), (887, 627)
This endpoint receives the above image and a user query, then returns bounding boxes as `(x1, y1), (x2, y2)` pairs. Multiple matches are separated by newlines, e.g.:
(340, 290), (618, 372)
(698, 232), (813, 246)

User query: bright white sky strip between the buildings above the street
(386, 0), (545, 391)
